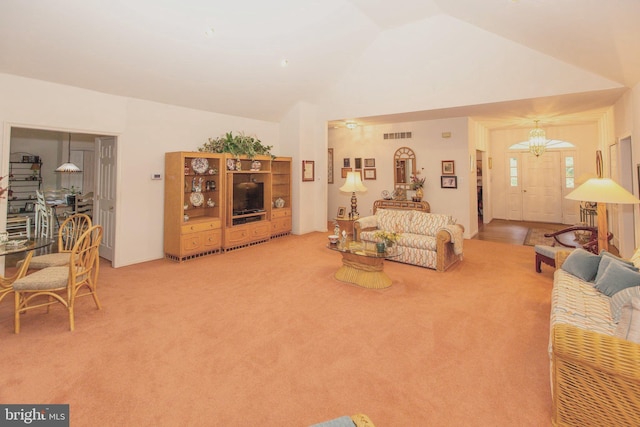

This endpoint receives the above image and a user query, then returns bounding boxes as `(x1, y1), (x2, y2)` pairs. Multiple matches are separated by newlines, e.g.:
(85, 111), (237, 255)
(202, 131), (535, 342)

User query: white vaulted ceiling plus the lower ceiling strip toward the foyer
(0, 0), (640, 127)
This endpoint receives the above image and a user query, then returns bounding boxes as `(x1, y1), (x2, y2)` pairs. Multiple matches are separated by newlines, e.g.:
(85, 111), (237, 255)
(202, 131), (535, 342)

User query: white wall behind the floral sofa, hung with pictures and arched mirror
(327, 118), (475, 237)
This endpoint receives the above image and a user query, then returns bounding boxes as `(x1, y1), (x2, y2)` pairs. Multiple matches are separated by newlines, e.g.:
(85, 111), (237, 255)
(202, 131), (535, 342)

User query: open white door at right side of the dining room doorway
(93, 136), (116, 261)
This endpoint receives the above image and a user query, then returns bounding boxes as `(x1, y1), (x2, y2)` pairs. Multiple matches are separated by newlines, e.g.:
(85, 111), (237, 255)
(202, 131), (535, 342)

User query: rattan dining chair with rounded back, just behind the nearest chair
(16, 214), (92, 270)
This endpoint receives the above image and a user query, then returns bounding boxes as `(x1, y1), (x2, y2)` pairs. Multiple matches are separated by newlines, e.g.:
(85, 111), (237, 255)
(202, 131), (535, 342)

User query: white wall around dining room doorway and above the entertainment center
(0, 74), (280, 267)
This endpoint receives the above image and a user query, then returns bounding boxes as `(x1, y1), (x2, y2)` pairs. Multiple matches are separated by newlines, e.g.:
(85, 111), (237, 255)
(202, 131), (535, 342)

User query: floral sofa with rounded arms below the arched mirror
(354, 209), (464, 271)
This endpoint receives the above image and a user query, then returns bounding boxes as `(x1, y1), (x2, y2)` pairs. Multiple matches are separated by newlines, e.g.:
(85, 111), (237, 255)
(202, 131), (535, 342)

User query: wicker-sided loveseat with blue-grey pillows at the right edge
(549, 249), (640, 426)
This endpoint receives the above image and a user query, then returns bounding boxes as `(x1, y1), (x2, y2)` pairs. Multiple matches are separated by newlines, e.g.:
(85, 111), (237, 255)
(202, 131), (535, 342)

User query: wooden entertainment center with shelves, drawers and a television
(164, 151), (291, 262)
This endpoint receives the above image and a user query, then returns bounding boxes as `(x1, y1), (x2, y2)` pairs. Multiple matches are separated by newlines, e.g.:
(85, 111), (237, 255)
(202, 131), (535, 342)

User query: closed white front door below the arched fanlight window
(522, 151), (562, 223)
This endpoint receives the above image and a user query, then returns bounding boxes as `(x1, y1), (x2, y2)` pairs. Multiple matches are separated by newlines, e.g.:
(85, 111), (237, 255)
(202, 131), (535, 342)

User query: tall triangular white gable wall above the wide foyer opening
(322, 15), (621, 119)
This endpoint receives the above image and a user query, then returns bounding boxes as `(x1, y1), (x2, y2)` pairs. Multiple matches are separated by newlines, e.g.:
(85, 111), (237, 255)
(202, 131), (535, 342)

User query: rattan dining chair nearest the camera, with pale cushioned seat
(13, 225), (103, 334)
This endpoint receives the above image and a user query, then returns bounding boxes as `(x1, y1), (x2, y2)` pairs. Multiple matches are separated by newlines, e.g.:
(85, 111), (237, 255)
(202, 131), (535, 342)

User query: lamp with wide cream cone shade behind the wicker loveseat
(565, 178), (640, 252)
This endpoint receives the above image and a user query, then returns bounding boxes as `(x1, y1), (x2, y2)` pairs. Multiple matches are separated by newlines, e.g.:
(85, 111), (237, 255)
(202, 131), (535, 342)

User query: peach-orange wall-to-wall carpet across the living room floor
(0, 233), (552, 427)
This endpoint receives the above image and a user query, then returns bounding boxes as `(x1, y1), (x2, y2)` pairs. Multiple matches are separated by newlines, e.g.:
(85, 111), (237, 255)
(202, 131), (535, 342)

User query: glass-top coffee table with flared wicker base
(327, 241), (400, 289)
